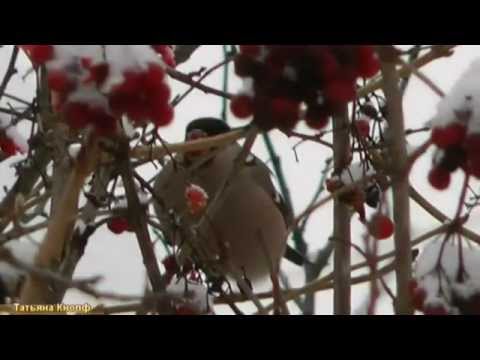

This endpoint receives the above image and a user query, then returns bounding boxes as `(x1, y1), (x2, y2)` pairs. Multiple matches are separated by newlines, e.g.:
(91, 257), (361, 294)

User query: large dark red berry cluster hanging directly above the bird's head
(231, 45), (380, 130)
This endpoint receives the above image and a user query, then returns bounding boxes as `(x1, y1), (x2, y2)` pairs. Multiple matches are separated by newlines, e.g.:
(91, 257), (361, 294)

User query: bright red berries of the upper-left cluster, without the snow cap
(22, 45), (174, 135)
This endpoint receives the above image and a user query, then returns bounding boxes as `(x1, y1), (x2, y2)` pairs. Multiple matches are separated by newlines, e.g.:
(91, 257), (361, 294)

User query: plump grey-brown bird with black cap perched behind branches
(154, 118), (305, 283)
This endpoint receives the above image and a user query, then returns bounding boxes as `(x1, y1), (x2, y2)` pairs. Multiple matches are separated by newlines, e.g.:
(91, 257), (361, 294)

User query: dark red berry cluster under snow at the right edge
(428, 105), (480, 190)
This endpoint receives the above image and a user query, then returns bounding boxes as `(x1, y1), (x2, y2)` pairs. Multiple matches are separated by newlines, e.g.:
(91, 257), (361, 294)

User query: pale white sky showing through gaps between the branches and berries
(0, 45), (480, 314)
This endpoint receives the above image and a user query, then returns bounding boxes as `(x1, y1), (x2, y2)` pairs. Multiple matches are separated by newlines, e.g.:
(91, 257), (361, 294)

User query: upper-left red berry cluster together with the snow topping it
(22, 45), (175, 136)
